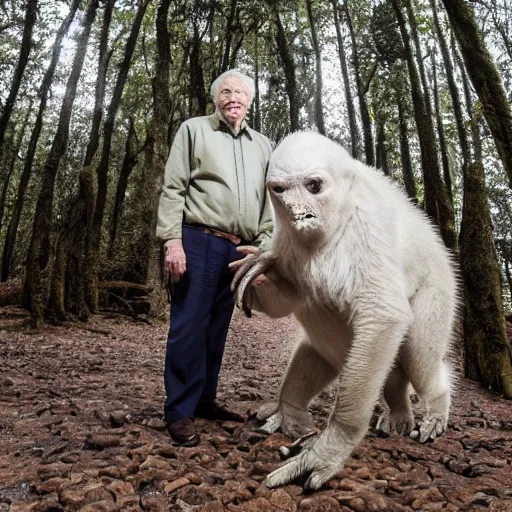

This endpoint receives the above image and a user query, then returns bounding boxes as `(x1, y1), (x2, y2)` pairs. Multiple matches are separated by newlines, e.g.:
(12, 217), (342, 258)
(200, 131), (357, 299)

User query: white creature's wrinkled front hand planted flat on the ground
(266, 427), (354, 490)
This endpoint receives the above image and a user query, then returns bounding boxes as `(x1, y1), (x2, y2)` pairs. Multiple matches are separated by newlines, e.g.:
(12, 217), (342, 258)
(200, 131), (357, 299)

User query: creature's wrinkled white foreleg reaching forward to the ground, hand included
(267, 302), (412, 489)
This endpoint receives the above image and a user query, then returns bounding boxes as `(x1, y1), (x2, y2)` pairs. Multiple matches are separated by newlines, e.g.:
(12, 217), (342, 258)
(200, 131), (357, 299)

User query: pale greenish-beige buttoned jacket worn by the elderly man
(156, 113), (272, 249)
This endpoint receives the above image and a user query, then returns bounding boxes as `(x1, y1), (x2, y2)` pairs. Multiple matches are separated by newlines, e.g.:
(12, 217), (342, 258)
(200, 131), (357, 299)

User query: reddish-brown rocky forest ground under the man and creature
(0, 308), (512, 512)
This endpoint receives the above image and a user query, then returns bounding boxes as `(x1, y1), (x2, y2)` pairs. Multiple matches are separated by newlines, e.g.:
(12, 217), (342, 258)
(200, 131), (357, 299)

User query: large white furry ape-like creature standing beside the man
(233, 132), (457, 489)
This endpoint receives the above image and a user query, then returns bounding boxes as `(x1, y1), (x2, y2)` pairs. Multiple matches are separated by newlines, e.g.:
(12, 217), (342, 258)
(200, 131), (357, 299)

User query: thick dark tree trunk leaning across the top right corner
(443, 0), (512, 187)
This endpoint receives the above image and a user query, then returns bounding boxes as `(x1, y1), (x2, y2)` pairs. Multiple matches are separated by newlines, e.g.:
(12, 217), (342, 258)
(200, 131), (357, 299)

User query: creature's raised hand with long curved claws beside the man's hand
(229, 246), (275, 316)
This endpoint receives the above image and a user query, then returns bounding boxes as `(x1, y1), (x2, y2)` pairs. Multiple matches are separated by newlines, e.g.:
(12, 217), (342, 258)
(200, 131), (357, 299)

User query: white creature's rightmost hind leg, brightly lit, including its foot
(400, 288), (453, 443)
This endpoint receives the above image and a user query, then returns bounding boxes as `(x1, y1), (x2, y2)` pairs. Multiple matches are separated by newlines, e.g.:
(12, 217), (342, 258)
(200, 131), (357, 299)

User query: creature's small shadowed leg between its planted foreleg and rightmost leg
(377, 364), (414, 436)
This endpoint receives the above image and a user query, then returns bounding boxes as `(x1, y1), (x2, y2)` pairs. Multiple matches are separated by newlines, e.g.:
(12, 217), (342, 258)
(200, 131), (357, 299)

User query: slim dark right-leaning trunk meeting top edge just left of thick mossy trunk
(86, 0), (149, 311)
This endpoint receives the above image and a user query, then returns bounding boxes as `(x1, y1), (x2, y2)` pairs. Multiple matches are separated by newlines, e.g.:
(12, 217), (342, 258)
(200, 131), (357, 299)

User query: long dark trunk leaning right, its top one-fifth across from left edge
(24, 0), (98, 327)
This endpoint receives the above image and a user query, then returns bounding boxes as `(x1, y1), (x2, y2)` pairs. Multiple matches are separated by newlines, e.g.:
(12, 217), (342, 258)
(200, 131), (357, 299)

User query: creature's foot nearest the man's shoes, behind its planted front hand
(256, 403), (315, 439)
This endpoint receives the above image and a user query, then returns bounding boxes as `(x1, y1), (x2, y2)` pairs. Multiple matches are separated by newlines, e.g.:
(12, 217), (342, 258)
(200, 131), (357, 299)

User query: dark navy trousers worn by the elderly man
(164, 226), (240, 423)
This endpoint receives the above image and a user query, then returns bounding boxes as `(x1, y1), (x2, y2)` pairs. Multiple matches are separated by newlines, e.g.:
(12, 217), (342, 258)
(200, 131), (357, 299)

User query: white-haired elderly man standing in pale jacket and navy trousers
(157, 70), (272, 446)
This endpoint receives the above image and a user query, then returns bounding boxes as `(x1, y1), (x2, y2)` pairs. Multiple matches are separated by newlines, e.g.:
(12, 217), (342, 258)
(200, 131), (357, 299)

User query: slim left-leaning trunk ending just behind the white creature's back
(391, 0), (457, 251)
